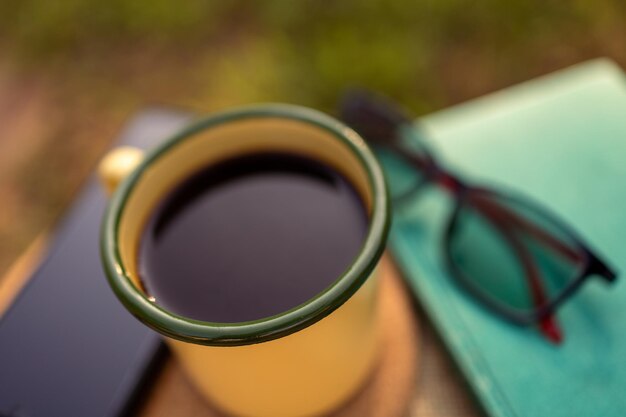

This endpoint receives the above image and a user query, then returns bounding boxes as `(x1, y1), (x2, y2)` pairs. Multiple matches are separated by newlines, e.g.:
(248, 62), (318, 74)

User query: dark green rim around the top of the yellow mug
(100, 104), (390, 346)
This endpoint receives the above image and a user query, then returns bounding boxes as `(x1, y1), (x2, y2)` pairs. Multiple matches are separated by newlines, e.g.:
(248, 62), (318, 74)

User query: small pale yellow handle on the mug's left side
(98, 146), (144, 195)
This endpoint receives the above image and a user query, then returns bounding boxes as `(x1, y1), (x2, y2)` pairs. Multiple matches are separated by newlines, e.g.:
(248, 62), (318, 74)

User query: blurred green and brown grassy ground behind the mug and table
(0, 0), (626, 272)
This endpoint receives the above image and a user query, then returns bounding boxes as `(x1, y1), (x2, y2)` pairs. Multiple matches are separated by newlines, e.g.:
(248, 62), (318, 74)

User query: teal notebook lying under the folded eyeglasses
(385, 60), (626, 417)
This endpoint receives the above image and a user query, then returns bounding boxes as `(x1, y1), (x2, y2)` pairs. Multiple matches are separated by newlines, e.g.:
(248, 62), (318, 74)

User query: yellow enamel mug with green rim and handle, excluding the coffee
(100, 104), (390, 417)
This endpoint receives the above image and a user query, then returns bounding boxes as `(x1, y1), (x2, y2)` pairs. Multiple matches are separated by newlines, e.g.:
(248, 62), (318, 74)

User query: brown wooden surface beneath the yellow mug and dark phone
(0, 238), (480, 417)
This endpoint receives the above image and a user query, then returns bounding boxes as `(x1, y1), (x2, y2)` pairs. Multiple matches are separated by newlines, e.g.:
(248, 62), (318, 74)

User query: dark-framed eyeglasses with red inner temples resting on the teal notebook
(341, 92), (617, 343)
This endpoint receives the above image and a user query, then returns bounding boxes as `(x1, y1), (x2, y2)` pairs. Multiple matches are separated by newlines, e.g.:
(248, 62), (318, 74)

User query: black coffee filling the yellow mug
(139, 153), (368, 323)
